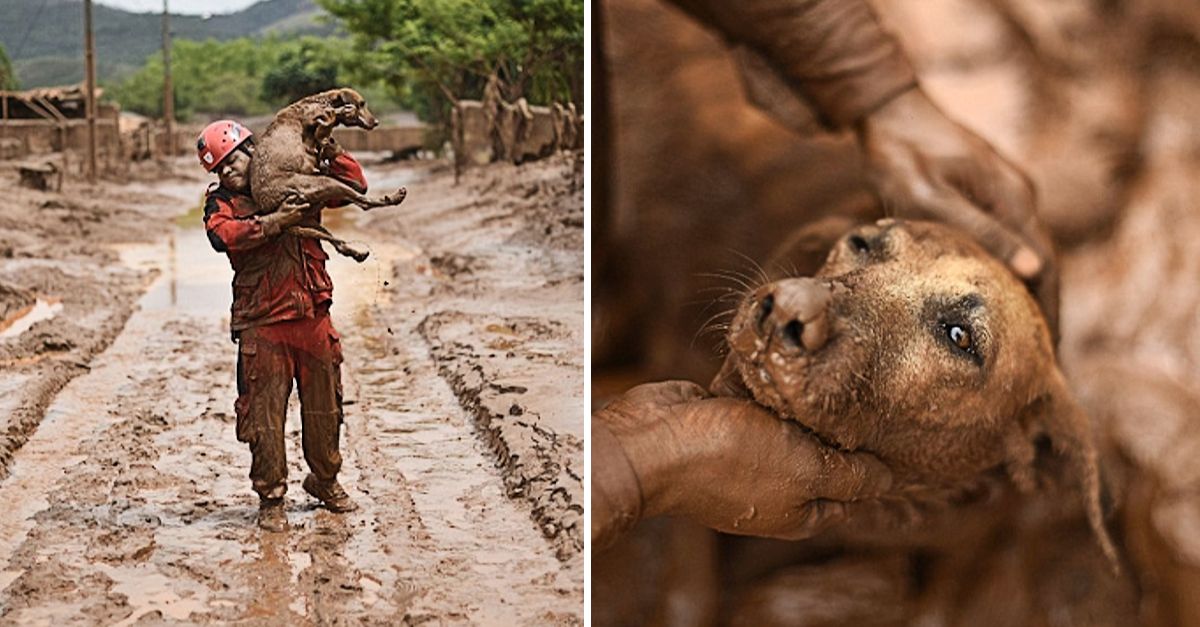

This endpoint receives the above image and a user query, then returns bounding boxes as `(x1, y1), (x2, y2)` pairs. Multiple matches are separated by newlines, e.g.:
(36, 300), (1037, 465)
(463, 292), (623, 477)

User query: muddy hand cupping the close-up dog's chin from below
(593, 381), (892, 539)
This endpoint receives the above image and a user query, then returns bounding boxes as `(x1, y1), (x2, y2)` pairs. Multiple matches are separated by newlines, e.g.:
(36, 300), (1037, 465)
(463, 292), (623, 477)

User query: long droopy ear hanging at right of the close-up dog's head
(1014, 369), (1118, 571)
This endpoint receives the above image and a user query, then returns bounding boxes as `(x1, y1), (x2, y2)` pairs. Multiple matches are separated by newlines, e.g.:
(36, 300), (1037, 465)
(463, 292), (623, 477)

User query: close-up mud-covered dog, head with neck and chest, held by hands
(696, 220), (1128, 625)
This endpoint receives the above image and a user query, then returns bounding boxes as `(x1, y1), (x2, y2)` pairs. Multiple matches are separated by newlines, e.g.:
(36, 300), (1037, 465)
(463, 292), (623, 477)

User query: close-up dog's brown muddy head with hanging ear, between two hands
(714, 220), (1106, 559)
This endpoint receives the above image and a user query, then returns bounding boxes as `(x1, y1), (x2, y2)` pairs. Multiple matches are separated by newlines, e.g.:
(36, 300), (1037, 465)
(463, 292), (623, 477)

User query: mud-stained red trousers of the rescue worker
(234, 311), (342, 498)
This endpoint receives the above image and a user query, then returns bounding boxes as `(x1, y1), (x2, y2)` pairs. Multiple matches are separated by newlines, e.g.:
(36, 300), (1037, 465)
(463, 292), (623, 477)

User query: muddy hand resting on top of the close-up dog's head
(856, 88), (1058, 336)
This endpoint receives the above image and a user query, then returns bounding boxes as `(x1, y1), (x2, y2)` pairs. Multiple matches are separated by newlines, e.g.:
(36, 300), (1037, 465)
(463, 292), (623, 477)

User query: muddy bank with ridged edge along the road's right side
(364, 154), (583, 566)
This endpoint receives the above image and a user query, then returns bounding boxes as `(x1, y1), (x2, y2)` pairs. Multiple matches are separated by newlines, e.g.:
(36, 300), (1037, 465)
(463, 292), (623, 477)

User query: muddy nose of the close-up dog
(757, 277), (833, 352)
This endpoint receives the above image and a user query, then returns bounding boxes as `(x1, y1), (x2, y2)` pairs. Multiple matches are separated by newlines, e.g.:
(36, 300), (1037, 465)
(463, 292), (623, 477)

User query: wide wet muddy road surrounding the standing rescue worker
(0, 155), (583, 625)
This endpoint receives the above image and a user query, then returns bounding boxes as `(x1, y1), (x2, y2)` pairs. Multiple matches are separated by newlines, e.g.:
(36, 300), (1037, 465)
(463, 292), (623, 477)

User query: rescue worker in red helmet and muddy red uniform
(197, 120), (367, 531)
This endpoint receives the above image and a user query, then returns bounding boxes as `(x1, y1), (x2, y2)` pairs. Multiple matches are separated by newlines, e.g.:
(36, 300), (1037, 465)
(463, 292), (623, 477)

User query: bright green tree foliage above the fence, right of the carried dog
(318, 0), (583, 124)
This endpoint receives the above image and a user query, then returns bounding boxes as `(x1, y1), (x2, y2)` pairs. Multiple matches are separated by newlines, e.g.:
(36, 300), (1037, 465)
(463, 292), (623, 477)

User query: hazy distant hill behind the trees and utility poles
(0, 0), (335, 88)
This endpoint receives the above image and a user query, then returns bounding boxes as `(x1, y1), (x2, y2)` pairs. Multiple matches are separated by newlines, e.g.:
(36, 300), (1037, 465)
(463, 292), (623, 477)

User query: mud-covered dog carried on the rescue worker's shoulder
(250, 88), (408, 262)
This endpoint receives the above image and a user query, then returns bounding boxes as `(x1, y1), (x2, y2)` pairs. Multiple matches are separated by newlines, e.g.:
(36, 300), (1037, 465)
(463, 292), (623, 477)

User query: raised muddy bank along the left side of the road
(0, 160), (178, 478)
